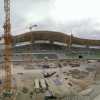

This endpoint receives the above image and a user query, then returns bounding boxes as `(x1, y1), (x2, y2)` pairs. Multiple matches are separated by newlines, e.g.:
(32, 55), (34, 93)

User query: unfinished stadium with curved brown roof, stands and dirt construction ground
(0, 31), (100, 100)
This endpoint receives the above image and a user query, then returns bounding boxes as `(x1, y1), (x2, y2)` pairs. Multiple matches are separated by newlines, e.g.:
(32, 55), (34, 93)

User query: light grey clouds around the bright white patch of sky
(0, 0), (100, 39)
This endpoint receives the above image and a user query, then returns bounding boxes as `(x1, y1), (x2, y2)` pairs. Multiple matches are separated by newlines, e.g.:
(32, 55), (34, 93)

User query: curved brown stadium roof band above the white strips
(14, 31), (100, 46)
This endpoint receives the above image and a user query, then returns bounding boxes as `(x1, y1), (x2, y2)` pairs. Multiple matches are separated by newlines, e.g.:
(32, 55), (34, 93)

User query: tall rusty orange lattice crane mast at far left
(4, 0), (12, 91)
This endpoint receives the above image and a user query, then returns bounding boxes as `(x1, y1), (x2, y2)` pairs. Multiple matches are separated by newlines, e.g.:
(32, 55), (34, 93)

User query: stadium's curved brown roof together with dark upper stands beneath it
(8, 31), (100, 58)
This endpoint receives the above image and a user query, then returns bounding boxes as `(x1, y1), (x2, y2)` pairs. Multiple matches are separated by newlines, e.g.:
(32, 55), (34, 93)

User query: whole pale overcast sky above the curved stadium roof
(0, 0), (100, 39)
